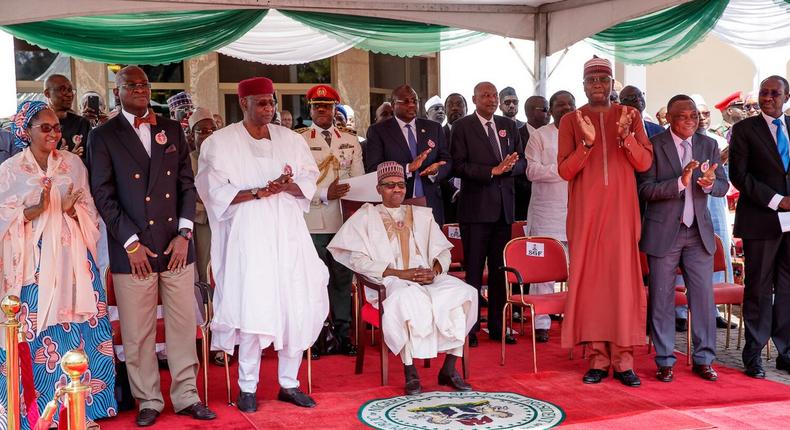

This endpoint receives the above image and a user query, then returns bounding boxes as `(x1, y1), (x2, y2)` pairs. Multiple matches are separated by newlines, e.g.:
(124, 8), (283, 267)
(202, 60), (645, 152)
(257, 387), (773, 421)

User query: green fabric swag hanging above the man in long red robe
(587, 0), (730, 64)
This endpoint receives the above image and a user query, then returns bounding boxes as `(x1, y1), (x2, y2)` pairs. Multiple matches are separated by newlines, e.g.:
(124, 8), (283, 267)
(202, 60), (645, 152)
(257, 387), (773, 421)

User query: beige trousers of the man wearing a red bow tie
(112, 264), (200, 412)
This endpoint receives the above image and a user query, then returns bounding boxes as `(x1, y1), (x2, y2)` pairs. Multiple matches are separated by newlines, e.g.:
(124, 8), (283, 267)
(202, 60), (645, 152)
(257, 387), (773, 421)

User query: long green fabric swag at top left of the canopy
(2, 9), (268, 65)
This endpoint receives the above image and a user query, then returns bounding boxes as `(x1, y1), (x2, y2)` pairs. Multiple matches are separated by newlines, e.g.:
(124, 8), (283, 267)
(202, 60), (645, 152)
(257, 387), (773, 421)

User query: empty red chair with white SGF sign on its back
(500, 237), (568, 373)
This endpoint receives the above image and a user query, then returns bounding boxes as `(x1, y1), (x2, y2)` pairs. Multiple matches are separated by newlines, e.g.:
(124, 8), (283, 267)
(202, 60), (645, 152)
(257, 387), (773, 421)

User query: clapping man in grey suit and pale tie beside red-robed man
(638, 95), (729, 382)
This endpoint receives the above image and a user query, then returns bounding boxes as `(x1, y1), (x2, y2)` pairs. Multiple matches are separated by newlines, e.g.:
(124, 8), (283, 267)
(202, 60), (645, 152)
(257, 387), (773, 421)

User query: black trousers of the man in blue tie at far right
(743, 233), (790, 366)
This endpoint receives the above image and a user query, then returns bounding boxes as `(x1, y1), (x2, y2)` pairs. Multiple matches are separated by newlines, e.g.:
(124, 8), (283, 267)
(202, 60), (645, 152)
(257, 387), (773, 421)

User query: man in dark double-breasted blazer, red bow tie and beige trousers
(88, 66), (216, 427)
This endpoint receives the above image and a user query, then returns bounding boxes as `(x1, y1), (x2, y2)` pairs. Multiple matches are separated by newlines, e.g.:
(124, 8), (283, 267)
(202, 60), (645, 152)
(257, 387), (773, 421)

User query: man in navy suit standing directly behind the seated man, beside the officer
(365, 85), (451, 225)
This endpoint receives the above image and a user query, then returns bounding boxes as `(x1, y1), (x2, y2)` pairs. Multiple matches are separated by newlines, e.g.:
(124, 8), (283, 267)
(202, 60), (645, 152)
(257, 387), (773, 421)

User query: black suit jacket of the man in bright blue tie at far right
(730, 115), (790, 239)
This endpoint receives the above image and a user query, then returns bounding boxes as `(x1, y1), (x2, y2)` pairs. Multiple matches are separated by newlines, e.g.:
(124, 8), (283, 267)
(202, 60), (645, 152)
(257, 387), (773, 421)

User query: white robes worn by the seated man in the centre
(327, 204), (477, 359)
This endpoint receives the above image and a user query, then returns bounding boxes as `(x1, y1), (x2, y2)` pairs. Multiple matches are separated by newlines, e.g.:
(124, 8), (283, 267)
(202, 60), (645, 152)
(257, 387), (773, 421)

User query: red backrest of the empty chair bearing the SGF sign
(503, 236), (568, 283)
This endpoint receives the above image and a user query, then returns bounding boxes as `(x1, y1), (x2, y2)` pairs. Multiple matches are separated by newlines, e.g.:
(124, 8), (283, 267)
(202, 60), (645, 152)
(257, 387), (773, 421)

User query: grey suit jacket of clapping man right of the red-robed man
(638, 130), (730, 257)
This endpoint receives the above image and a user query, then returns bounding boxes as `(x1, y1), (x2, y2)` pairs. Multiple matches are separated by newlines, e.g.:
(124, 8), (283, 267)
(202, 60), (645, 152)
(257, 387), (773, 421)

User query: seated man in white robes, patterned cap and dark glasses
(327, 161), (477, 395)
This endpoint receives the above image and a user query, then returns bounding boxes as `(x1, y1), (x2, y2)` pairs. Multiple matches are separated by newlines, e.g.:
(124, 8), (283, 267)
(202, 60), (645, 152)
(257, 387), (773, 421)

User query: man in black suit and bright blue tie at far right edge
(730, 76), (790, 378)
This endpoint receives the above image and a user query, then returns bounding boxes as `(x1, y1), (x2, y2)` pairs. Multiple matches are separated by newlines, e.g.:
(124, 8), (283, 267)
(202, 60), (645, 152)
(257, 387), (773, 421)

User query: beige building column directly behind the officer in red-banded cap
(332, 48), (370, 136)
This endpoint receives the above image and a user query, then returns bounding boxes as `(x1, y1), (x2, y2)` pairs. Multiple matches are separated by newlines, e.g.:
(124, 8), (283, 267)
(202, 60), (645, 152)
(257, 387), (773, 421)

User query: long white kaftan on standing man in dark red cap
(200, 122), (329, 355)
